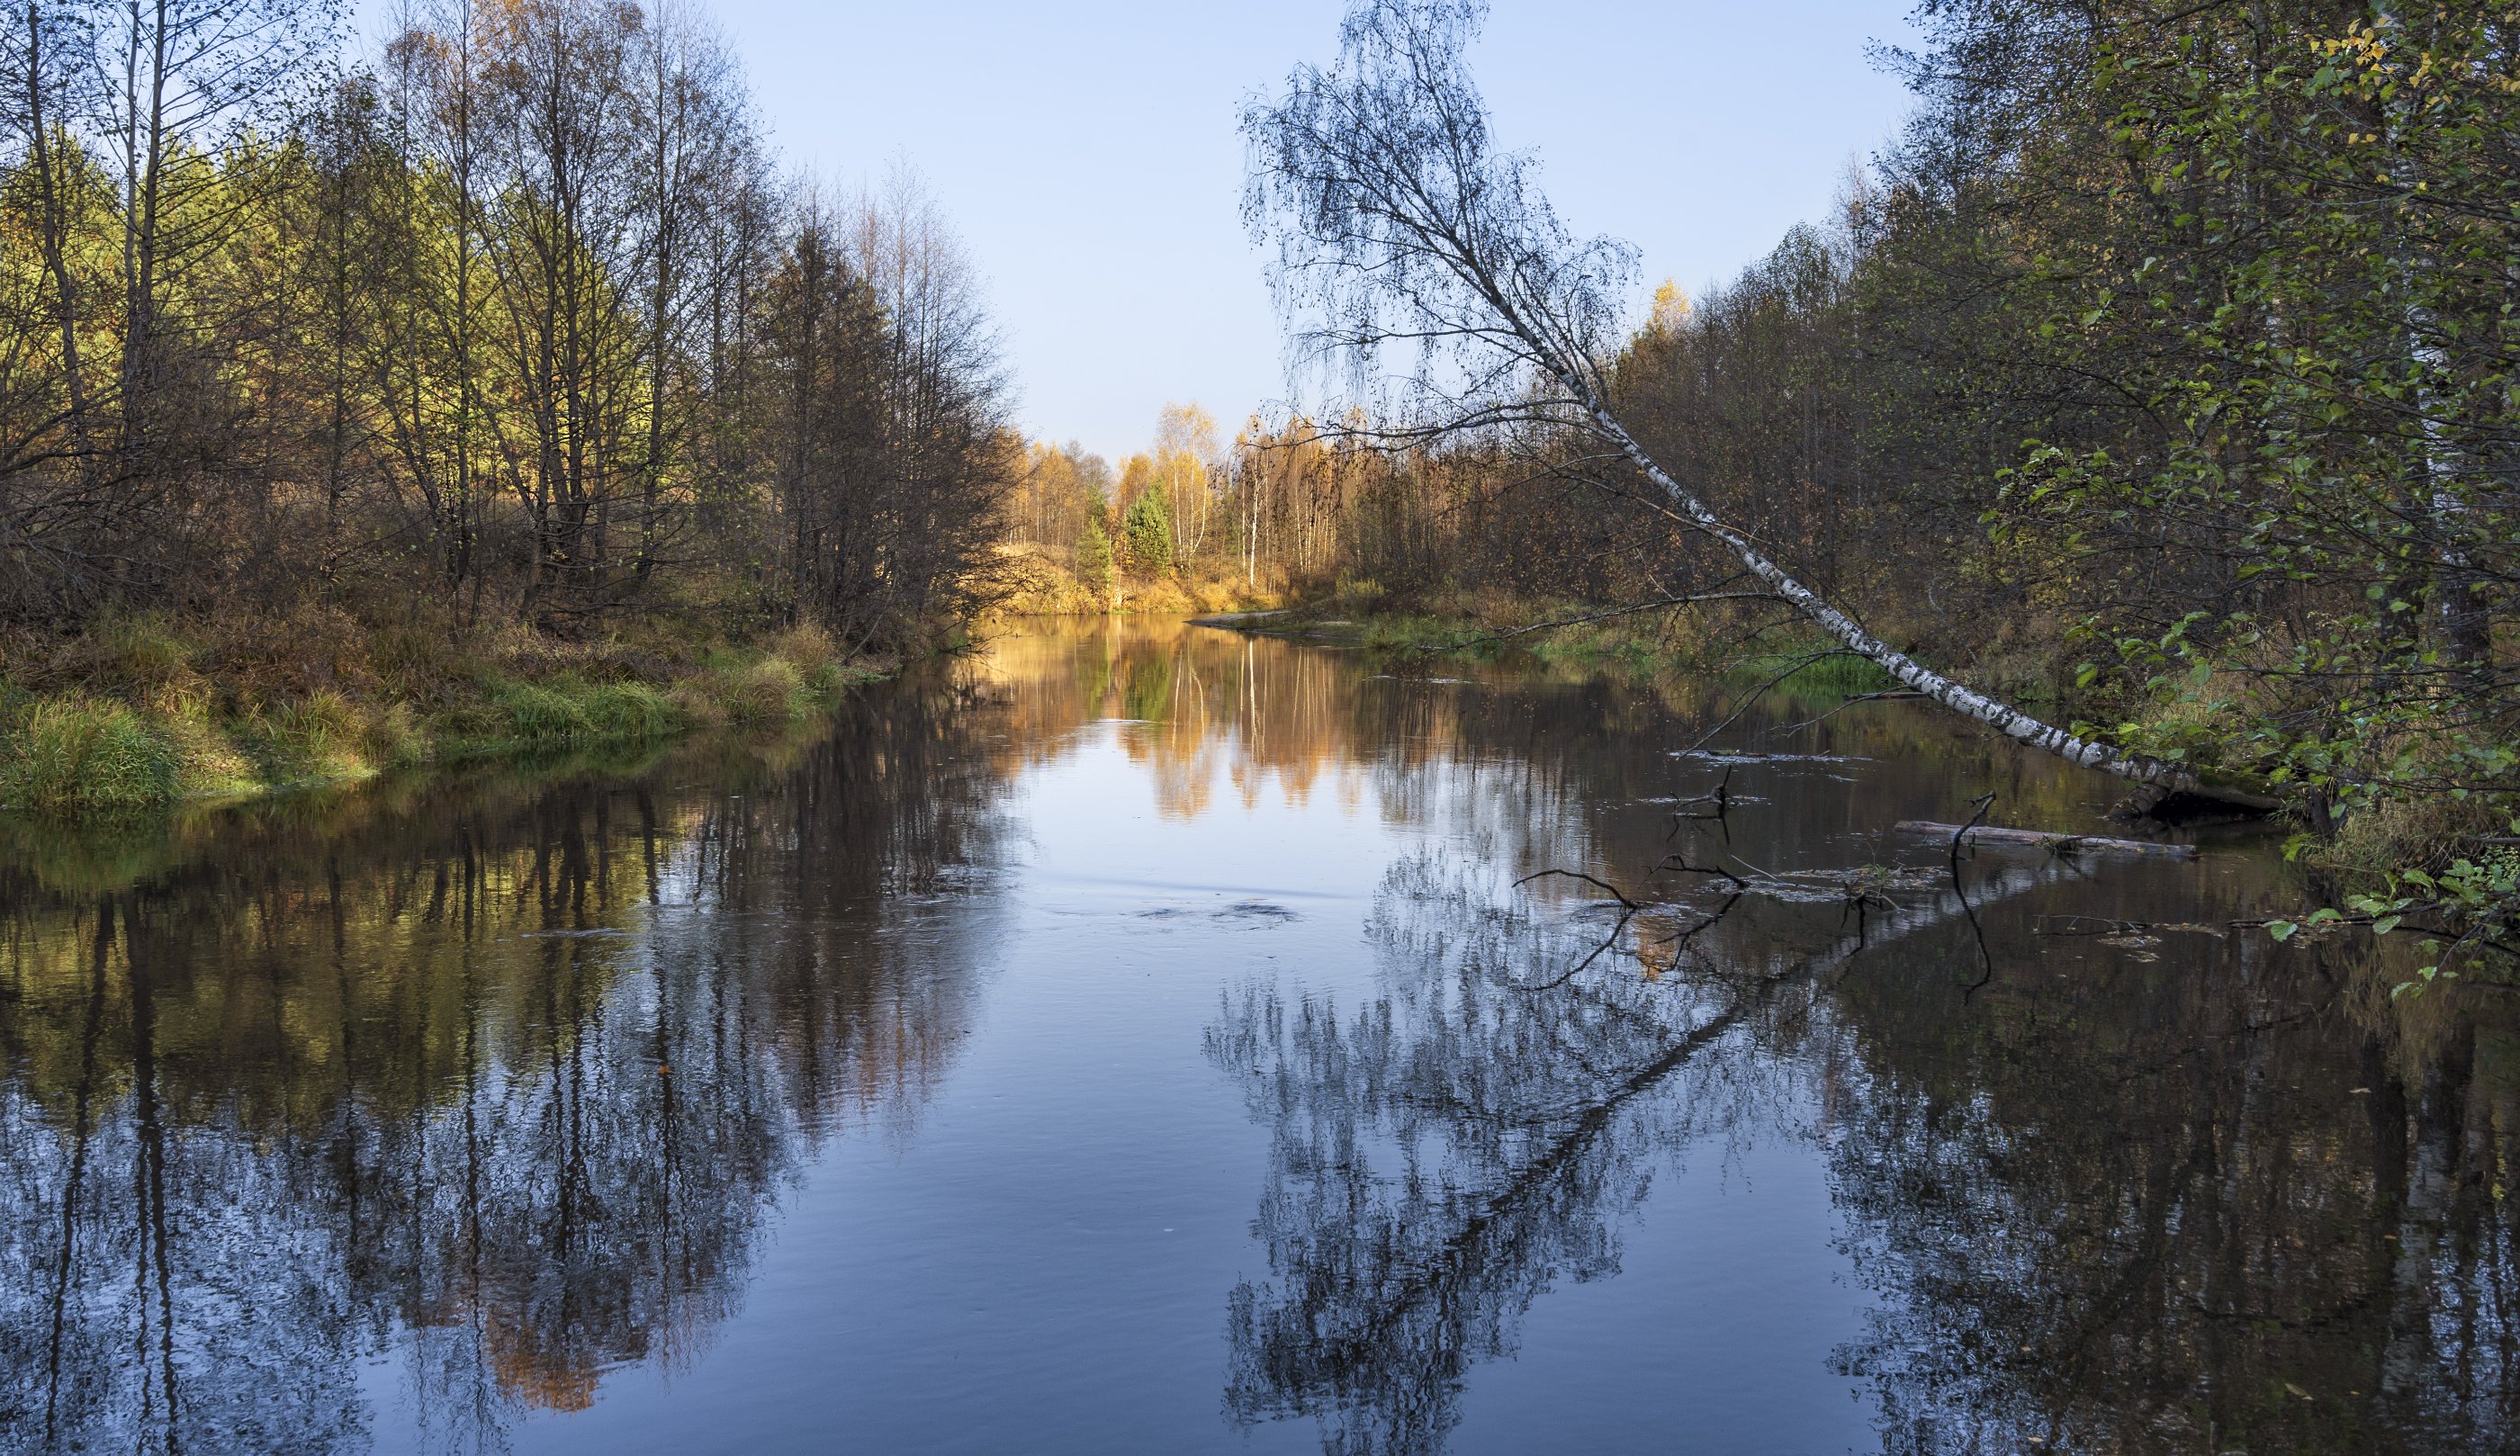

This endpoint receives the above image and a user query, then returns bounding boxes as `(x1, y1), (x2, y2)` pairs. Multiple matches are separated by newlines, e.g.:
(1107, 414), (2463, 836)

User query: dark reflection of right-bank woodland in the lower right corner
(1832, 912), (2520, 1453)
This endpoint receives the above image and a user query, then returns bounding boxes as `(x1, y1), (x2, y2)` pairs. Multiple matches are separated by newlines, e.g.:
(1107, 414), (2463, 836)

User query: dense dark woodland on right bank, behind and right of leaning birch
(1613, 0), (2520, 902)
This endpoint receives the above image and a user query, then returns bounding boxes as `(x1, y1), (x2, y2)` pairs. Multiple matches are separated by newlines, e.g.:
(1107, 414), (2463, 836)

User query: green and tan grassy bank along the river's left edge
(0, 615), (882, 819)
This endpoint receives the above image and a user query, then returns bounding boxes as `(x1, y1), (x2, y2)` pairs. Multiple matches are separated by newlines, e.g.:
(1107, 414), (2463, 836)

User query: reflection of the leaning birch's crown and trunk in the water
(1207, 859), (2036, 1453)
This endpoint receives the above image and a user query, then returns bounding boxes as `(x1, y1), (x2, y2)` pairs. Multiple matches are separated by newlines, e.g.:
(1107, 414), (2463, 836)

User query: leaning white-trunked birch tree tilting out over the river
(1242, 0), (2281, 809)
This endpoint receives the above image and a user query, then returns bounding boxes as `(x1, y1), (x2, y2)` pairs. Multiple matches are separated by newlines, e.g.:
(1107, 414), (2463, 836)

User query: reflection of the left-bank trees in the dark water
(0, 675), (998, 1451)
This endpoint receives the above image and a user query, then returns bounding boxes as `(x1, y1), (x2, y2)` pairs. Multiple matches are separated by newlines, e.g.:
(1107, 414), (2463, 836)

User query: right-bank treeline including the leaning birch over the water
(1189, 0), (2520, 949)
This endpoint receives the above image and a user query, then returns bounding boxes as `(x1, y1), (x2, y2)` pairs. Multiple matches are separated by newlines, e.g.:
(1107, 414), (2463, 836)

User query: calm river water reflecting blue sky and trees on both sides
(0, 620), (2520, 1456)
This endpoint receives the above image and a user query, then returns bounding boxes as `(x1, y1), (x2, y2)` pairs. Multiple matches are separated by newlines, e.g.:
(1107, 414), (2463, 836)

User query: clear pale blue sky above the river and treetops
(363, 0), (1912, 461)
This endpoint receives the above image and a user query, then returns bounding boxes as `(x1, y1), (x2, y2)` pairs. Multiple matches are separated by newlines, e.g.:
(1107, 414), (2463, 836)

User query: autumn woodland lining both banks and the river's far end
(0, 0), (2520, 941)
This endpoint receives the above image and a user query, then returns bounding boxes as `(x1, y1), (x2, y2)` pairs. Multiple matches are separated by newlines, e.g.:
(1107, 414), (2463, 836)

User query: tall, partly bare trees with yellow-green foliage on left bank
(0, 0), (1021, 652)
